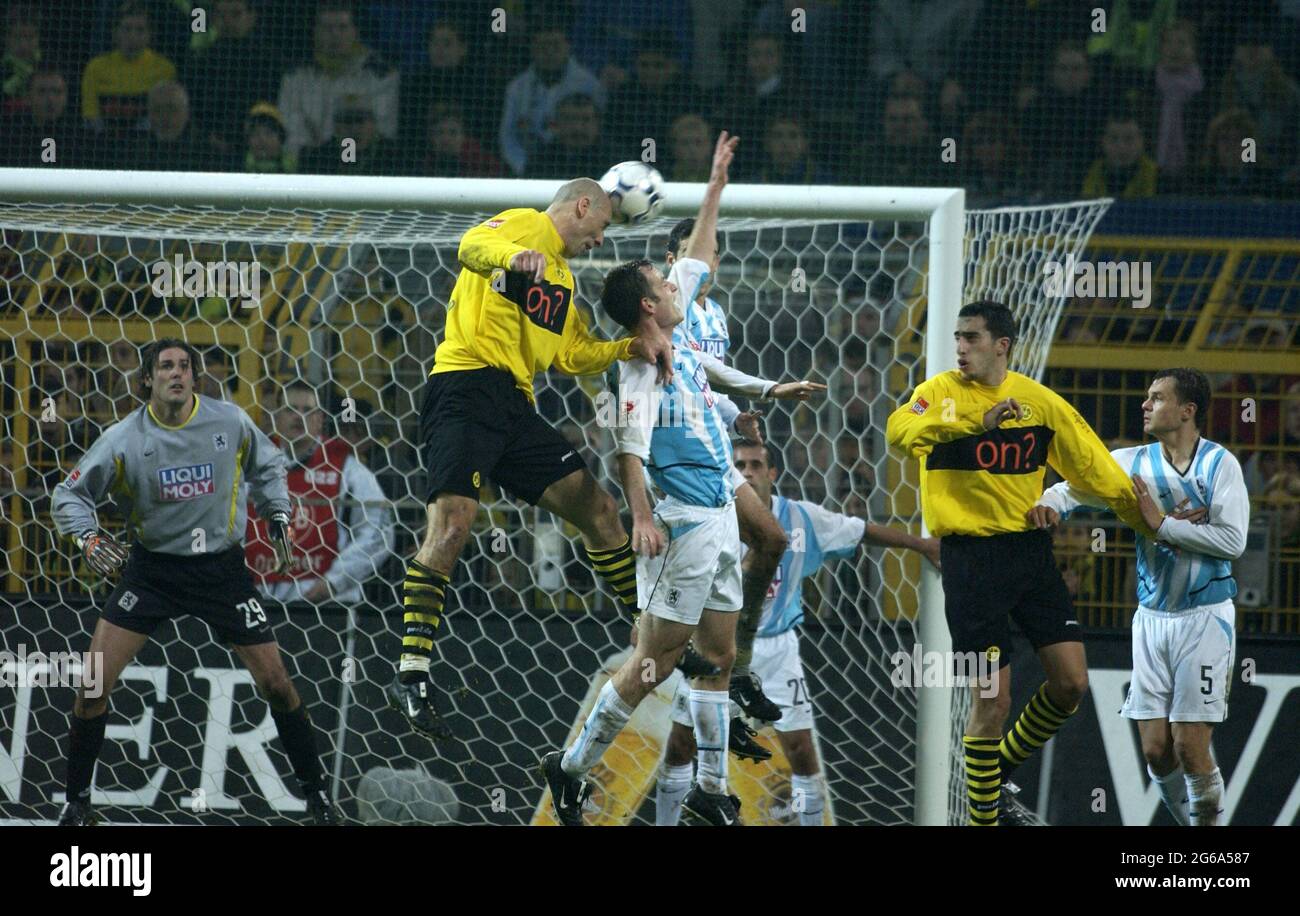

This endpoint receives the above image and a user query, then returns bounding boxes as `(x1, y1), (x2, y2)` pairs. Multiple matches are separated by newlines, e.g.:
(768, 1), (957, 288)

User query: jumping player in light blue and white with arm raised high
(541, 131), (741, 826)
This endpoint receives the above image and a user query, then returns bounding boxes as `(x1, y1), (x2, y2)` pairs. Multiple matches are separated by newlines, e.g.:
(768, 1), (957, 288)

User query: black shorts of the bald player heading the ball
(420, 369), (586, 505)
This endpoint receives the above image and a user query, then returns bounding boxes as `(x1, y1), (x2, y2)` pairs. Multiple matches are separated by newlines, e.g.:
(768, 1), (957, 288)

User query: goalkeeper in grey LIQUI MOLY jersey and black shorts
(51, 338), (339, 826)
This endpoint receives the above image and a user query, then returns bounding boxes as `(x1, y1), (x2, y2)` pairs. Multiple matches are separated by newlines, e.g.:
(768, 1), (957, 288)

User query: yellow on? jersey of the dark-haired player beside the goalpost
(885, 369), (1151, 537)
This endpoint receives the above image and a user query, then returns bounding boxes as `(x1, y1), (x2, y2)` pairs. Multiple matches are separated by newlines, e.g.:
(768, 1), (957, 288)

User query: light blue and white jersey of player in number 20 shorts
(741, 492), (867, 637)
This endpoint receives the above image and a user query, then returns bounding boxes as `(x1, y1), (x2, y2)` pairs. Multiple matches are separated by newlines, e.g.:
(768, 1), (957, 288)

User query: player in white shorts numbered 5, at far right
(1027, 369), (1251, 826)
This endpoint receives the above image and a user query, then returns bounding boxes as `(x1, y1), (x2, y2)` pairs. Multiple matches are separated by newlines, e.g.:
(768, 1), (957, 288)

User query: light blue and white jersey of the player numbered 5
(1039, 439), (1251, 611)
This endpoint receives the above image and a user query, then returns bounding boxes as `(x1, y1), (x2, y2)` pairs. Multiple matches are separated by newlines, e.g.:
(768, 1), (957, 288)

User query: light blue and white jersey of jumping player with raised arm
(614, 257), (736, 508)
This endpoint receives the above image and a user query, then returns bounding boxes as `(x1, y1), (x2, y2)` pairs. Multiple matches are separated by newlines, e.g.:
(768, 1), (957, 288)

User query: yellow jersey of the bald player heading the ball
(429, 208), (632, 401)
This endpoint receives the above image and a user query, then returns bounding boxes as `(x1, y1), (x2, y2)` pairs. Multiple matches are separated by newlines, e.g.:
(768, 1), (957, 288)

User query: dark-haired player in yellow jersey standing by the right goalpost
(885, 301), (1148, 826)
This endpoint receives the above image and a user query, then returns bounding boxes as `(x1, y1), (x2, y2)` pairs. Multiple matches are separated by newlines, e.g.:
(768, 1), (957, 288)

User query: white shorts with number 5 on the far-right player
(1119, 602), (1236, 722)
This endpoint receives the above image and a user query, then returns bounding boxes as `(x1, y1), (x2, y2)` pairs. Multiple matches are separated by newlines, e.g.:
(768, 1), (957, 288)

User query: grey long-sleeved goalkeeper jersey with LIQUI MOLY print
(51, 395), (289, 556)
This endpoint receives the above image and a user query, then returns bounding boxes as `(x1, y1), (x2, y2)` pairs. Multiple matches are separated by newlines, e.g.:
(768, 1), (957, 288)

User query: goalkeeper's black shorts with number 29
(100, 544), (276, 646)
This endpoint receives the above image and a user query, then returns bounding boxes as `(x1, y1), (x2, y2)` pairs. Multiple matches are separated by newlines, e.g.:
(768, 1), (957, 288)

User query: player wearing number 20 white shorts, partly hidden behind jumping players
(655, 439), (939, 826)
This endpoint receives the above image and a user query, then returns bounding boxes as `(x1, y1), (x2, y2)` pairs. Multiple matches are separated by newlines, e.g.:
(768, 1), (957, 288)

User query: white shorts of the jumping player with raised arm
(637, 496), (741, 626)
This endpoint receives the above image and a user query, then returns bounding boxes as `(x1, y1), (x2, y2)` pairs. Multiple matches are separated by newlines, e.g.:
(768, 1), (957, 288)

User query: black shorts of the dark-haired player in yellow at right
(939, 530), (1083, 667)
